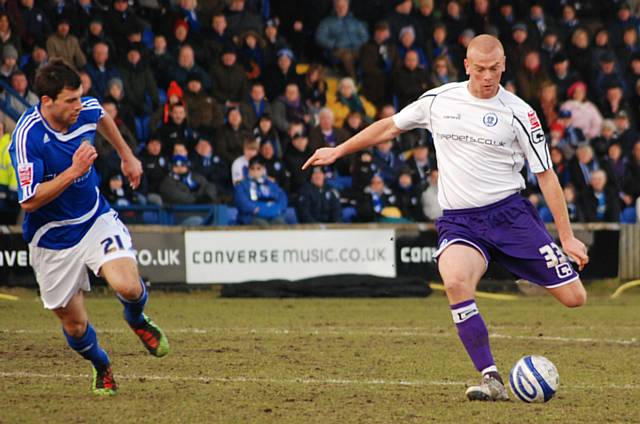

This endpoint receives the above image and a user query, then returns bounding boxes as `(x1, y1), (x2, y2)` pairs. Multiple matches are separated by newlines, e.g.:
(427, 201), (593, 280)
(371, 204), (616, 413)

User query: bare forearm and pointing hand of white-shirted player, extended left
(302, 118), (403, 169)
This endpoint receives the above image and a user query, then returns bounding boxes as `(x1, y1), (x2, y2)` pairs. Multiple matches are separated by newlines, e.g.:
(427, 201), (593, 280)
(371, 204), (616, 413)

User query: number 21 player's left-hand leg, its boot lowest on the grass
(53, 290), (117, 395)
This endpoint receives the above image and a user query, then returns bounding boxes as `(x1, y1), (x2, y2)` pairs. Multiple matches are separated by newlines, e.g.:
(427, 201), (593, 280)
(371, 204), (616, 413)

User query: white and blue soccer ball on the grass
(509, 355), (560, 403)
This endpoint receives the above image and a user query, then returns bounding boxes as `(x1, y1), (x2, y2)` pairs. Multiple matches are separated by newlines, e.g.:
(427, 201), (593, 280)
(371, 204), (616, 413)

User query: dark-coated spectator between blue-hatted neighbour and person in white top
(189, 136), (233, 196)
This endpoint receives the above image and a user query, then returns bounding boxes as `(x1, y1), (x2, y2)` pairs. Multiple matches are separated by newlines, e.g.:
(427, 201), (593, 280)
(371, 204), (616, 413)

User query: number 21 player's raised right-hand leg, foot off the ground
(99, 257), (169, 357)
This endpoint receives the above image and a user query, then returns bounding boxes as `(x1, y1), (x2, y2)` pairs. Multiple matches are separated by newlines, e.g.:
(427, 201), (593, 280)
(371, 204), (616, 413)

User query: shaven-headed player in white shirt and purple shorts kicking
(304, 35), (589, 400)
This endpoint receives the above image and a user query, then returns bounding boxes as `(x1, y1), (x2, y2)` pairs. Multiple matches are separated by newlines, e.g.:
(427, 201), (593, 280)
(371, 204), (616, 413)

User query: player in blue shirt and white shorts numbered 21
(9, 60), (169, 395)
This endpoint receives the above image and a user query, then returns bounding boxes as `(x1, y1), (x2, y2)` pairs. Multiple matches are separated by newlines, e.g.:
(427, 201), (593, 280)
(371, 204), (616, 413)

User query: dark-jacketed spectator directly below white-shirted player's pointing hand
(295, 166), (342, 224)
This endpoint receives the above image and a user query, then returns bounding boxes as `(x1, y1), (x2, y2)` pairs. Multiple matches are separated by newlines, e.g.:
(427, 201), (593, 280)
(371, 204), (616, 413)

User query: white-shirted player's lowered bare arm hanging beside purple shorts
(536, 169), (589, 271)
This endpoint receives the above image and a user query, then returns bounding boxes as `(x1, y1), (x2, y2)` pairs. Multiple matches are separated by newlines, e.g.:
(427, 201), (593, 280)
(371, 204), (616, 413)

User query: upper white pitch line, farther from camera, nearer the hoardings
(0, 327), (640, 346)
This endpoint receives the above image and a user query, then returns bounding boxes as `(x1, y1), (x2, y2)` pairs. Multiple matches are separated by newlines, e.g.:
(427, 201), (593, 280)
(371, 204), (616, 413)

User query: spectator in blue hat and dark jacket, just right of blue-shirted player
(160, 155), (218, 205)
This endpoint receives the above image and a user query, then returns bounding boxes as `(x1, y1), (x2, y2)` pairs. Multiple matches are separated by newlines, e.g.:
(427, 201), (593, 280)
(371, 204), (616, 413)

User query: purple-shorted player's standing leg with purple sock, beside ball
(438, 244), (508, 400)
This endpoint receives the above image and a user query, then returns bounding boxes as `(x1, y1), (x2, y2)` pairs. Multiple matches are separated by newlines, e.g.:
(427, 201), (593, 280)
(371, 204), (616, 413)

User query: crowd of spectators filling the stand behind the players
(0, 0), (640, 224)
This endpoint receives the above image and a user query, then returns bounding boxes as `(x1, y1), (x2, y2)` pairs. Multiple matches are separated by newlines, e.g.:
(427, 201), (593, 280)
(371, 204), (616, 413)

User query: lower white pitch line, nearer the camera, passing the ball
(0, 371), (640, 390)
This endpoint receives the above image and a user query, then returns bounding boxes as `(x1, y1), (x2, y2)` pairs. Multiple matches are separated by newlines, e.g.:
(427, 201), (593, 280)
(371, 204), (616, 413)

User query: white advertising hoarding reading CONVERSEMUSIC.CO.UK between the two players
(185, 229), (396, 284)
